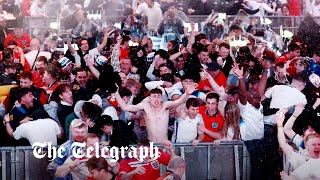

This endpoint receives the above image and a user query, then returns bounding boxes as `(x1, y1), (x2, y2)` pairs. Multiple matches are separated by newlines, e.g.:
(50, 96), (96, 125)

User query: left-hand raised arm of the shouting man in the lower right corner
(276, 109), (293, 156)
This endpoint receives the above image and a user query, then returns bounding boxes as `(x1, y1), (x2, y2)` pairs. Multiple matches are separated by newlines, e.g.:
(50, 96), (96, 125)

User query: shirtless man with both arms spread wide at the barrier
(114, 85), (196, 143)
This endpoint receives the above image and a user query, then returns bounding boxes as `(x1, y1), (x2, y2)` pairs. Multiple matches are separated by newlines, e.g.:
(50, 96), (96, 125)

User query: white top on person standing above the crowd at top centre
(136, 2), (163, 31)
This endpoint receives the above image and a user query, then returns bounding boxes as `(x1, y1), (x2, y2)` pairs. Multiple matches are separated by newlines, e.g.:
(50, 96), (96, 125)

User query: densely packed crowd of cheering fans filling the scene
(0, 0), (320, 180)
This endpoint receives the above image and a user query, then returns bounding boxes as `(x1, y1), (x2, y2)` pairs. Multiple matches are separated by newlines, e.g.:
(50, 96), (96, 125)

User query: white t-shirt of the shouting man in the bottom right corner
(292, 158), (320, 180)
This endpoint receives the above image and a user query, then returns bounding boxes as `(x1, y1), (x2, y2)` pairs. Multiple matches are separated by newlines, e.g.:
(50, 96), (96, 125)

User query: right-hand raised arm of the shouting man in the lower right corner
(283, 104), (305, 139)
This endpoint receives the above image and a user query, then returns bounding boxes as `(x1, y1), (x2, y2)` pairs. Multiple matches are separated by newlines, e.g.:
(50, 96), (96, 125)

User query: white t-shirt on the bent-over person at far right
(264, 85), (307, 109)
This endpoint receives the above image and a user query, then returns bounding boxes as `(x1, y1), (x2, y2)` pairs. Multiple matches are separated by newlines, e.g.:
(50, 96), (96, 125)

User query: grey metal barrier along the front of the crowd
(0, 141), (250, 180)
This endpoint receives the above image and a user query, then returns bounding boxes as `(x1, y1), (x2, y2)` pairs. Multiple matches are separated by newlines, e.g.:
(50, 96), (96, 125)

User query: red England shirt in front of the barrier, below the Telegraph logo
(119, 149), (170, 180)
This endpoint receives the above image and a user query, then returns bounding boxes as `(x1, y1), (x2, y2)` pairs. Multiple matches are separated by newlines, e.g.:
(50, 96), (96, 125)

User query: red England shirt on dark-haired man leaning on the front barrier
(199, 106), (224, 142)
